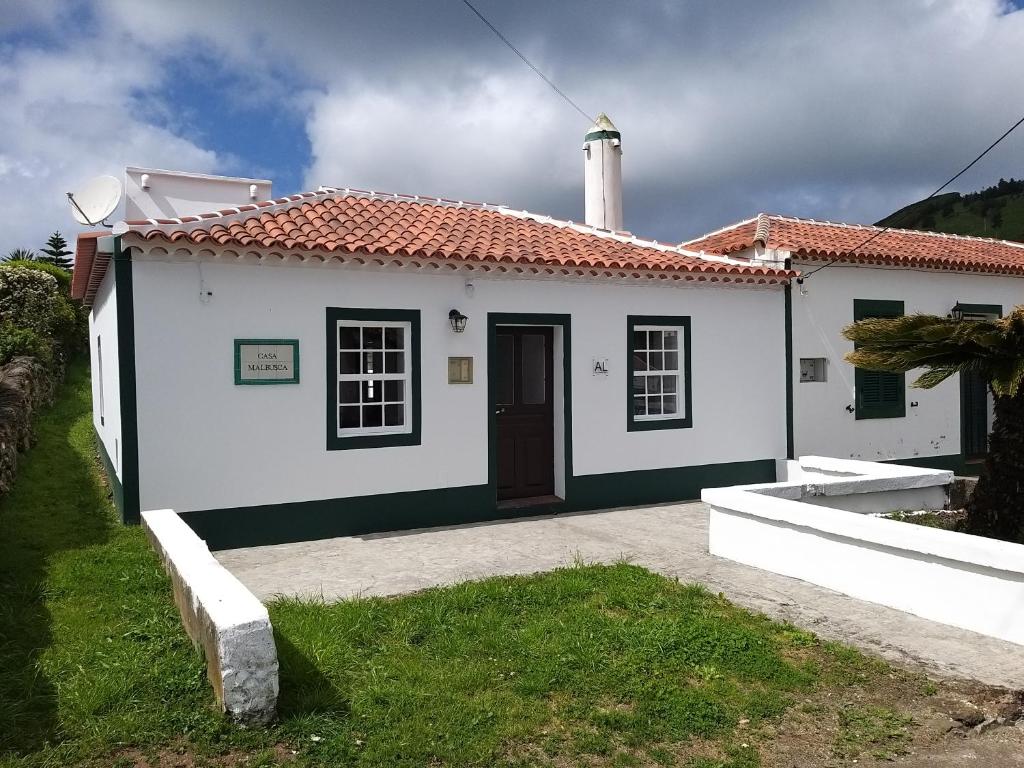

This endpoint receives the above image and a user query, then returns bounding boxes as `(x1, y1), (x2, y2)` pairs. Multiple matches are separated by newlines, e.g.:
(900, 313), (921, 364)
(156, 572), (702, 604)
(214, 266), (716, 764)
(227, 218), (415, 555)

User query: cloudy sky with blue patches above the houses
(0, 0), (1024, 253)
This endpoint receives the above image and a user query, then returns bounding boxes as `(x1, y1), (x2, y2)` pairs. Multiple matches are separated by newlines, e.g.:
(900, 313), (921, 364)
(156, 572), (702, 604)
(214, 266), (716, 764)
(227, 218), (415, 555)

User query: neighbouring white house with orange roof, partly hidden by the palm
(682, 214), (1024, 471)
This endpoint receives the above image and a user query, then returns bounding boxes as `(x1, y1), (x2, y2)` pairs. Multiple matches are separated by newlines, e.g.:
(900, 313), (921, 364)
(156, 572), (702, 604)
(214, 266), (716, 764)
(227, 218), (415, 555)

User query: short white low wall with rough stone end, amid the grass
(142, 509), (279, 723)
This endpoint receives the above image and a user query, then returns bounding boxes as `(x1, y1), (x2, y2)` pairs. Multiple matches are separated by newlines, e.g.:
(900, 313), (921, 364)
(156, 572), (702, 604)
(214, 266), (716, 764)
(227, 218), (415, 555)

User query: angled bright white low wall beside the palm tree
(701, 457), (1024, 644)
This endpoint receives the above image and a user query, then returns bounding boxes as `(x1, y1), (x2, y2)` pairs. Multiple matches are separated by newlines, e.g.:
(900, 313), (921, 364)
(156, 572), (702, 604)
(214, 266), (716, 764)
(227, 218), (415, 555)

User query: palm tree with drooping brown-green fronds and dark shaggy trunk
(843, 305), (1024, 544)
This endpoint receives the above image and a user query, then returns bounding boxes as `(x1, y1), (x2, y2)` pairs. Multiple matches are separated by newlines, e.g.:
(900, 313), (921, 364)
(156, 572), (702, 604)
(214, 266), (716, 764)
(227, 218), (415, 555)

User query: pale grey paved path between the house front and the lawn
(216, 503), (1024, 688)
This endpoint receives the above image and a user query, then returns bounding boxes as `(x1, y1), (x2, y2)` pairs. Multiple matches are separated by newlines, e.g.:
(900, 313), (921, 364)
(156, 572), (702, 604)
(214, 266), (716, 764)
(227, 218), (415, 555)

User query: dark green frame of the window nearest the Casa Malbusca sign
(324, 307), (423, 451)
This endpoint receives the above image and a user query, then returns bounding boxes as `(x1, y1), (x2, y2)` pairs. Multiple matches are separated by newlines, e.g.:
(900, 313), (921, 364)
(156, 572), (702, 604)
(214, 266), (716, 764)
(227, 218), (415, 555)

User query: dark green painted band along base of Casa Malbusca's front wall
(181, 459), (775, 550)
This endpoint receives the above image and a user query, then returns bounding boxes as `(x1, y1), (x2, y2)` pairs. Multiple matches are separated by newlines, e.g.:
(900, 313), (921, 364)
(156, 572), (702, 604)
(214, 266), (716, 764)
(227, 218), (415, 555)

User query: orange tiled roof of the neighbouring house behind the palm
(682, 213), (1024, 274)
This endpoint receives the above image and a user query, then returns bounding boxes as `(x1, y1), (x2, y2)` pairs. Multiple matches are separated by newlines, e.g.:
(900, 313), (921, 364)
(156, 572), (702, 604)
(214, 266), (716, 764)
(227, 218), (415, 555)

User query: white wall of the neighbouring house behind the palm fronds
(793, 263), (1024, 461)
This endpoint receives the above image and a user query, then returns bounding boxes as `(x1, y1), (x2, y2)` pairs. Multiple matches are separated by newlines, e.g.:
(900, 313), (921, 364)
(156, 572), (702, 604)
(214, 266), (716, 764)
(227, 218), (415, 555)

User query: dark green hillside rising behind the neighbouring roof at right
(878, 179), (1024, 242)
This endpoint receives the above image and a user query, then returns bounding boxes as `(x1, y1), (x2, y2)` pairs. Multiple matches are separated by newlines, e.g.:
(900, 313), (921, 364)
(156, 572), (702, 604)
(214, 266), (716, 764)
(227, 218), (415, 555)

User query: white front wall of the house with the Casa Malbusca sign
(133, 254), (785, 518)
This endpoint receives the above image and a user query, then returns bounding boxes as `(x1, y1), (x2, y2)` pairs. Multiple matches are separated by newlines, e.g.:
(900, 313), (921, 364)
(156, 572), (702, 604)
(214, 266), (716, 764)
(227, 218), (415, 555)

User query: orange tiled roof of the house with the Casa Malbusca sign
(70, 189), (796, 305)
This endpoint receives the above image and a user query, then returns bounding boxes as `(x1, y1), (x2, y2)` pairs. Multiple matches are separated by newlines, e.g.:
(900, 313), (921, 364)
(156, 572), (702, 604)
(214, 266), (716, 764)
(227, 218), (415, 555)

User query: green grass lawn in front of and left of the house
(0, 365), (1007, 768)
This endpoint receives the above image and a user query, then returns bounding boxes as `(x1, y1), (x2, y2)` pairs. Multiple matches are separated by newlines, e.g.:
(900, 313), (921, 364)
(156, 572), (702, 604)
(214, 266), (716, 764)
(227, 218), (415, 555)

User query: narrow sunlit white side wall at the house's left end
(89, 264), (122, 479)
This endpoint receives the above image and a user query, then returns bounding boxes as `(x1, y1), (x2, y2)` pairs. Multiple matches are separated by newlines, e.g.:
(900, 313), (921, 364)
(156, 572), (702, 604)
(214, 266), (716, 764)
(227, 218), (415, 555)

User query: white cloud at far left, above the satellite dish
(0, 32), (218, 253)
